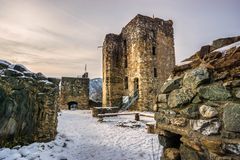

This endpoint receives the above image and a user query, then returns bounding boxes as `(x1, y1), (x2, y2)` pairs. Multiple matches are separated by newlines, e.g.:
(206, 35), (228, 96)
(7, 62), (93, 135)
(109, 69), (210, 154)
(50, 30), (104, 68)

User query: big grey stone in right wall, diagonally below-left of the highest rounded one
(168, 88), (195, 108)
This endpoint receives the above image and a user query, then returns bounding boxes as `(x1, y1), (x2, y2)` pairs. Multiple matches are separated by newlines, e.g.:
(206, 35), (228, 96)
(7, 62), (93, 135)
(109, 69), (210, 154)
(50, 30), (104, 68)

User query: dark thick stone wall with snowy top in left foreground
(0, 61), (60, 147)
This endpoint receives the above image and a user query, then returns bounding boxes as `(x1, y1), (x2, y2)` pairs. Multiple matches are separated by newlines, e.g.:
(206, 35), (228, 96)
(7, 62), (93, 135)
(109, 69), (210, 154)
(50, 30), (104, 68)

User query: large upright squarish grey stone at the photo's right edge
(223, 102), (240, 132)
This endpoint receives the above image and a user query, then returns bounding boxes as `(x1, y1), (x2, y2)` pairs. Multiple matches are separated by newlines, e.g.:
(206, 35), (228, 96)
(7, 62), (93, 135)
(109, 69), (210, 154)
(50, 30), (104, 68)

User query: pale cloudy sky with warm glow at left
(0, 0), (240, 78)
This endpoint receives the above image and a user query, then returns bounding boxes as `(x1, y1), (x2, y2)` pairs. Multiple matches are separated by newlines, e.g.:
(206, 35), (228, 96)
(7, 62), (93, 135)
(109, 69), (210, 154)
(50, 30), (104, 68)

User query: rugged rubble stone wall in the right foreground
(155, 37), (240, 160)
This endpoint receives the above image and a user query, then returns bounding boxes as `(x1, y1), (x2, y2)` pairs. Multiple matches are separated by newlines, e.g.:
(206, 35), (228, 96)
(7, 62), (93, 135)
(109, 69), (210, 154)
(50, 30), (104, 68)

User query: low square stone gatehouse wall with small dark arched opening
(60, 77), (89, 109)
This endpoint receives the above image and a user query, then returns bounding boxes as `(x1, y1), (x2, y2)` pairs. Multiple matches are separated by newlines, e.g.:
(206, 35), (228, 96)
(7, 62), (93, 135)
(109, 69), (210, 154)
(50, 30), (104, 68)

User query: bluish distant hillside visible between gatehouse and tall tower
(89, 78), (102, 102)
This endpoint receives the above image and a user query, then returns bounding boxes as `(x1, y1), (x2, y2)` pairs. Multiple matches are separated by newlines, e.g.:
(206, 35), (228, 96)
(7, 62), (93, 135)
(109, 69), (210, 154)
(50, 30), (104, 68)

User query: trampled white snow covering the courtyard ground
(0, 110), (162, 160)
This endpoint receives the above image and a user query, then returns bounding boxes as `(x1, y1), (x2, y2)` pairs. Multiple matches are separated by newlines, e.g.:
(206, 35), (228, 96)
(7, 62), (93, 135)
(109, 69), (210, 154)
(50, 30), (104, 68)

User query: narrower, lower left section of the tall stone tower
(102, 34), (123, 107)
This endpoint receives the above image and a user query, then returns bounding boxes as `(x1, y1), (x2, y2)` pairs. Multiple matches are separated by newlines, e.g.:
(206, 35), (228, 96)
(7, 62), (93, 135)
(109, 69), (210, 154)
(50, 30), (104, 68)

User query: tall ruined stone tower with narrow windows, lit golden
(102, 15), (175, 111)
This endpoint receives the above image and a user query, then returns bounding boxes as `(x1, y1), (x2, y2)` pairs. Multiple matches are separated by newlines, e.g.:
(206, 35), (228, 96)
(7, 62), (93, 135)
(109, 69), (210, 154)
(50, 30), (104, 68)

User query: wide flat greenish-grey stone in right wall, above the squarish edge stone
(198, 84), (231, 101)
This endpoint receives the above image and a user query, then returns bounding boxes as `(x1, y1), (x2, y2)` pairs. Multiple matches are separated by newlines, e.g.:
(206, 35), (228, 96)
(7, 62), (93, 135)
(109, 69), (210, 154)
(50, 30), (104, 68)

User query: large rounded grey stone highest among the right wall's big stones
(183, 68), (209, 89)
